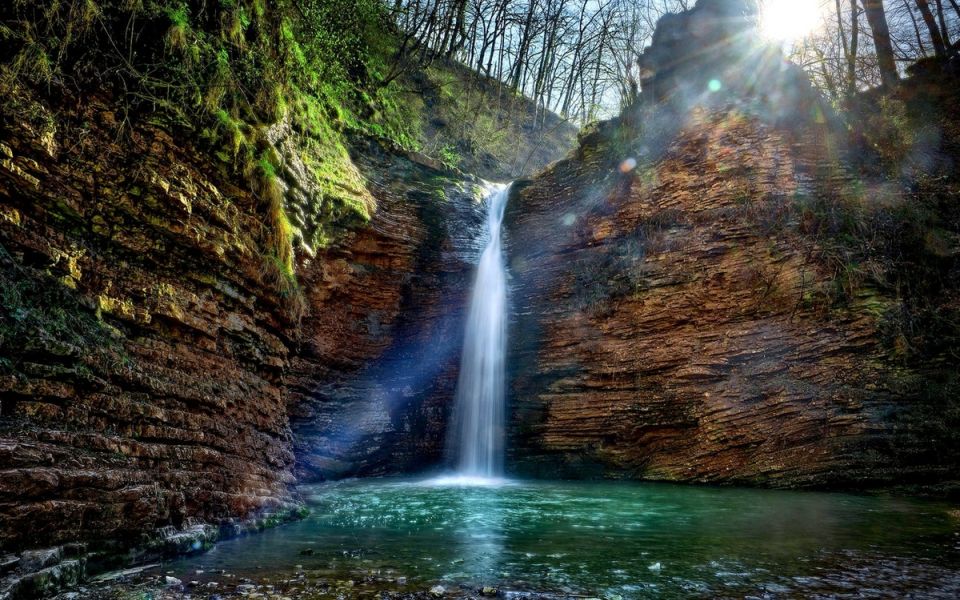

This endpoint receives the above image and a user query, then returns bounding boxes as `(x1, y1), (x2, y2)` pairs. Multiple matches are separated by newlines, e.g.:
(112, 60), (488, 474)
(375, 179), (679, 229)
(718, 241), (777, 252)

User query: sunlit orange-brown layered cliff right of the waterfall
(506, 1), (957, 487)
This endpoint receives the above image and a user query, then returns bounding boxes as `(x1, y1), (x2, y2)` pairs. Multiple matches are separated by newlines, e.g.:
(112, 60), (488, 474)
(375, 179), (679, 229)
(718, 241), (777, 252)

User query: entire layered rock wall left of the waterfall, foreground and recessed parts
(0, 89), (488, 550)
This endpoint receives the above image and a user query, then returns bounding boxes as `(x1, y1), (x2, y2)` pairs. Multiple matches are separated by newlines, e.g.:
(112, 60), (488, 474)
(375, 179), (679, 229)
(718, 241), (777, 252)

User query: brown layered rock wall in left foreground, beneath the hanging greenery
(0, 102), (294, 548)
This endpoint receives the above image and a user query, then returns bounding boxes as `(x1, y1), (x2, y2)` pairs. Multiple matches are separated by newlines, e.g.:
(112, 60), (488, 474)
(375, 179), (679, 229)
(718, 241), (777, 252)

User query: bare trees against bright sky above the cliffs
(391, 0), (960, 118)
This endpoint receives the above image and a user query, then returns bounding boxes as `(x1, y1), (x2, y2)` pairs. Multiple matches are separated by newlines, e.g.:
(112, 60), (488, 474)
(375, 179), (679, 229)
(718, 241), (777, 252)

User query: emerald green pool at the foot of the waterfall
(170, 479), (960, 598)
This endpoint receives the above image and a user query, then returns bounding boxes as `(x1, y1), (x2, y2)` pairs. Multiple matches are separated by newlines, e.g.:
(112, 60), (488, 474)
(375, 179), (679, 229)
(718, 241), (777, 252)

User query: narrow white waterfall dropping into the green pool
(450, 186), (510, 478)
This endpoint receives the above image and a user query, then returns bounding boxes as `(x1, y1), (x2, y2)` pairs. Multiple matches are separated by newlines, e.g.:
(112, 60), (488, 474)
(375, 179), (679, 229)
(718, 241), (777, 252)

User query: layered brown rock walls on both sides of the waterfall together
(0, 2), (960, 593)
